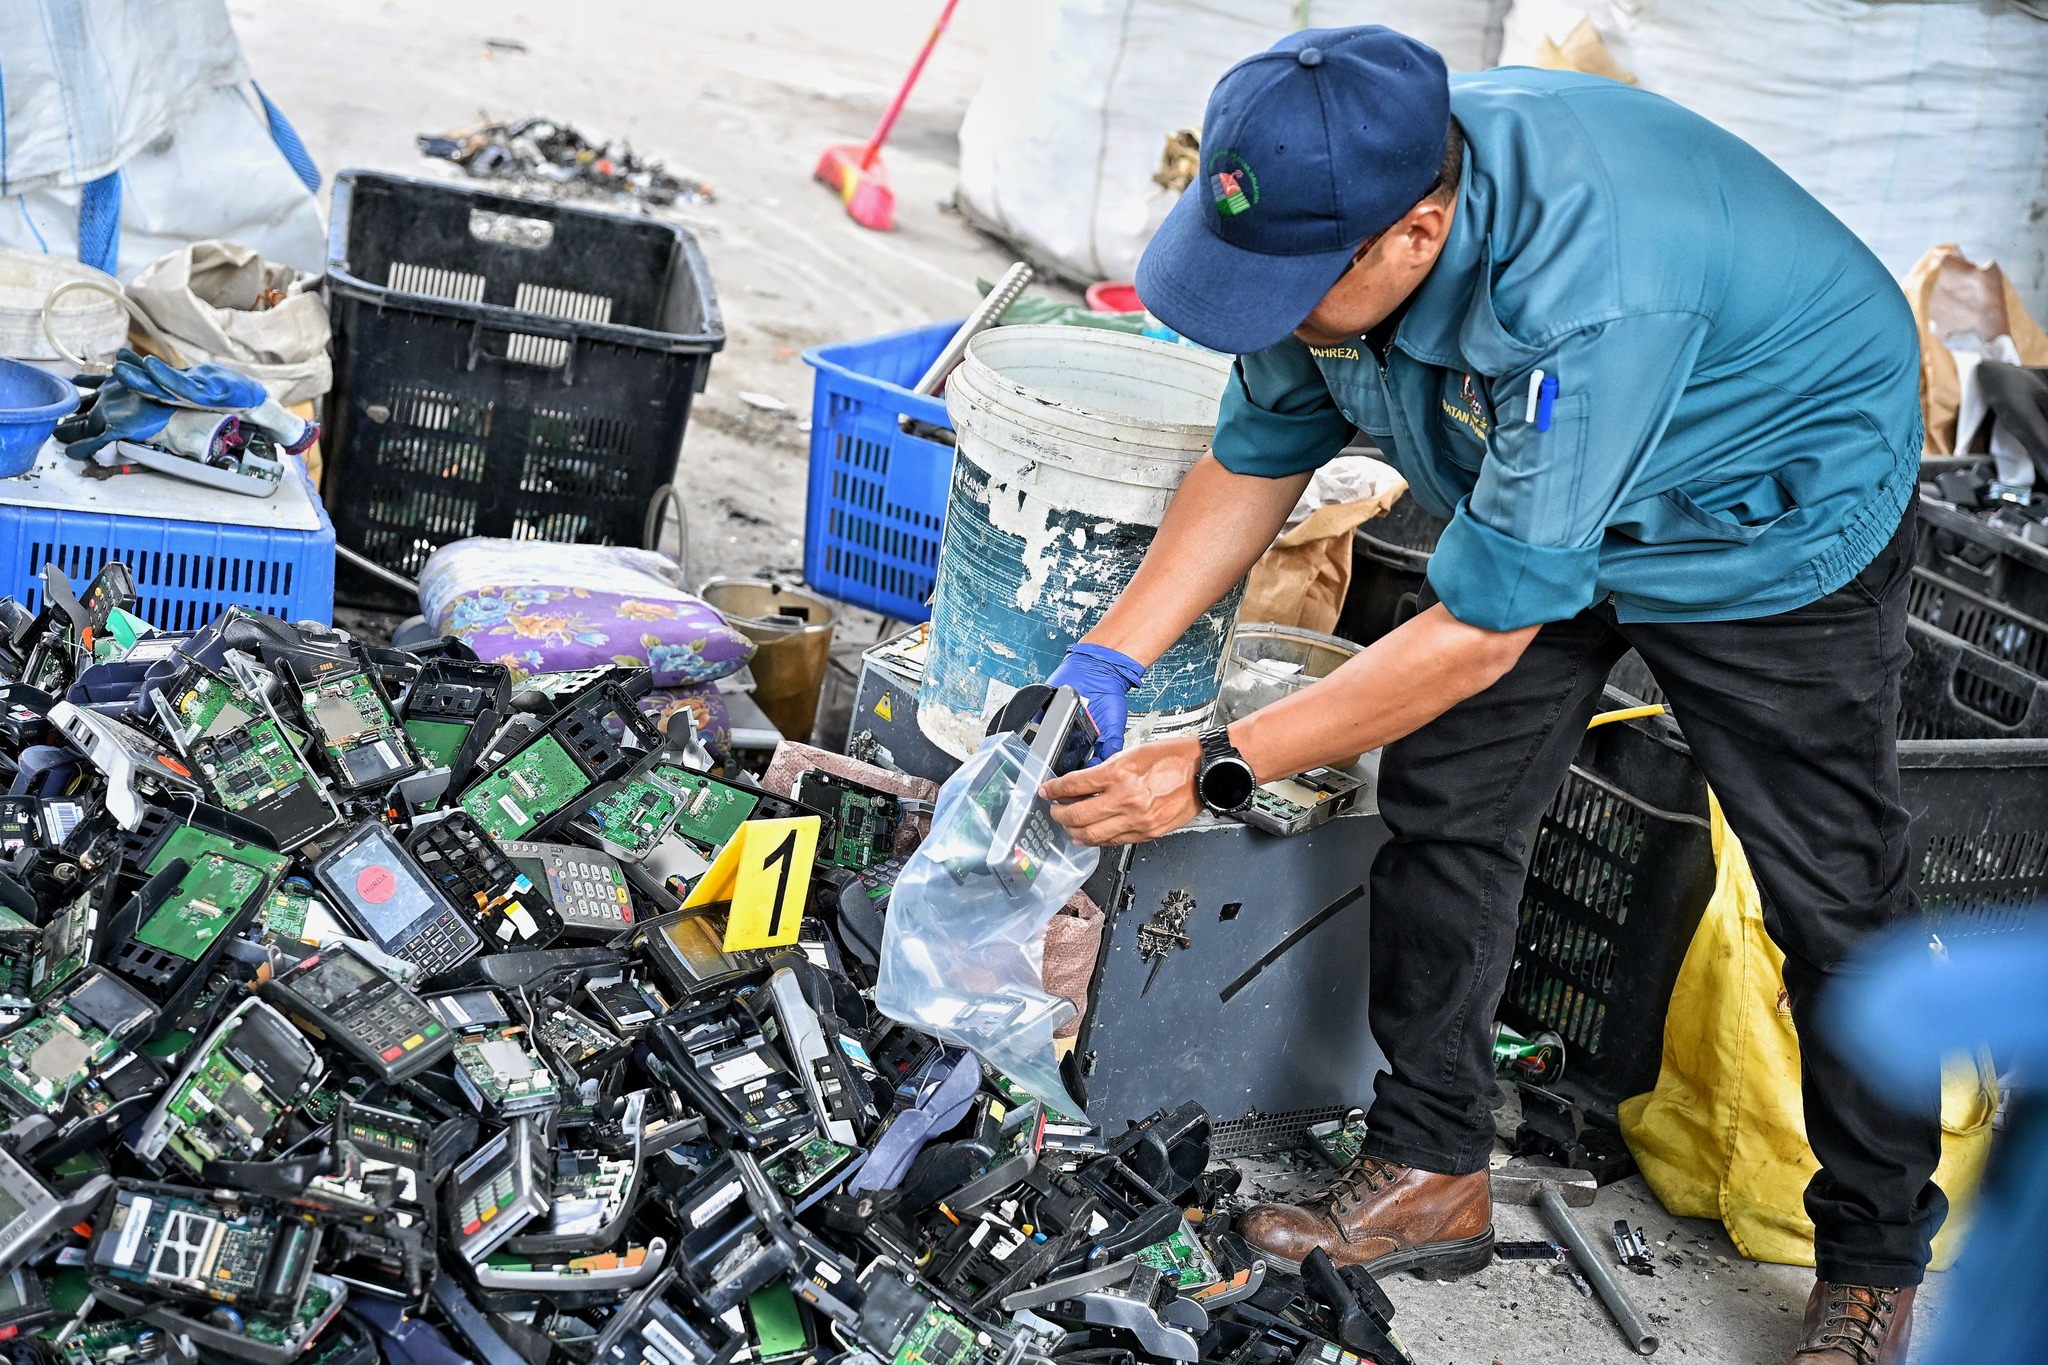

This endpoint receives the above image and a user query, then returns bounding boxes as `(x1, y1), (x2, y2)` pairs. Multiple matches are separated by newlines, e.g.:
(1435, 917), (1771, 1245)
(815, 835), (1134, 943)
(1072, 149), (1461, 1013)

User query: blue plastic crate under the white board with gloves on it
(0, 463), (334, 630)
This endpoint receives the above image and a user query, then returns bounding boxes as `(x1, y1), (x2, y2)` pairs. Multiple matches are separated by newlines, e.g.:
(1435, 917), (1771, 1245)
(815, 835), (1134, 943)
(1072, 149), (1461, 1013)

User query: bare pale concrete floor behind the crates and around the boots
(229, 0), (1942, 1365)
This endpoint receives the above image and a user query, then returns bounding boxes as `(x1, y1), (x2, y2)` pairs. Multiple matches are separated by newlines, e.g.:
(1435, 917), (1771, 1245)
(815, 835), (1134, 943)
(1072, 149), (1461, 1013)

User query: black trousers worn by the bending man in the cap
(1366, 512), (1948, 1287)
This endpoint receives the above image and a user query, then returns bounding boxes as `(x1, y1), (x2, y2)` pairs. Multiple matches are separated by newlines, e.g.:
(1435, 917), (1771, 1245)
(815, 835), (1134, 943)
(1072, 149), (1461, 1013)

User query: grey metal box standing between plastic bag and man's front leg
(1077, 792), (1386, 1154)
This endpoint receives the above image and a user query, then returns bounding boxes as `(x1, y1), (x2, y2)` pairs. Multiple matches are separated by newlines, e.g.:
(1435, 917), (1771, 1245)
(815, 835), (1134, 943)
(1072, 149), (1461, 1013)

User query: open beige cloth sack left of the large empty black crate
(127, 241), (334, 405)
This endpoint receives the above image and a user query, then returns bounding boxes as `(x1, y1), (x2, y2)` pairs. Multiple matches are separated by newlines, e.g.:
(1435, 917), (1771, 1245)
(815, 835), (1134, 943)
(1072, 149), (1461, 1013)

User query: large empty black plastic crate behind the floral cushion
(324, 170), (725, 606)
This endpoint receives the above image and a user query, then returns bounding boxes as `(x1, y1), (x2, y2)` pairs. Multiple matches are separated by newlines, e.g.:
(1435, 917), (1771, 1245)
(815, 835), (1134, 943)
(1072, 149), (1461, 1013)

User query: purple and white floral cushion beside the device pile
(420, 536), (754, 688)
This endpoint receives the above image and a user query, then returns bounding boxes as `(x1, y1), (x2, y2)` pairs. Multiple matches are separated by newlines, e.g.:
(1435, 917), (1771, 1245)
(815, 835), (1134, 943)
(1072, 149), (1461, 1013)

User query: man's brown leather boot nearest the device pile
(1237, 1156), (1493, 1279)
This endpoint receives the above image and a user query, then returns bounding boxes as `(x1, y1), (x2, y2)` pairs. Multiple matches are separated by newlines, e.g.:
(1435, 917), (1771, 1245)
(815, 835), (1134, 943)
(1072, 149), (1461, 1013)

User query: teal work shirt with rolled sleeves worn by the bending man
(1212, 68), (1921, 630)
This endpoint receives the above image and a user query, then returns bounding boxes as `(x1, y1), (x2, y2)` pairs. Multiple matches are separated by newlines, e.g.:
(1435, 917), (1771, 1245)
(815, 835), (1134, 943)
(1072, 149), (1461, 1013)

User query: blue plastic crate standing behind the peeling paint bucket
(803, 321), (961, 622)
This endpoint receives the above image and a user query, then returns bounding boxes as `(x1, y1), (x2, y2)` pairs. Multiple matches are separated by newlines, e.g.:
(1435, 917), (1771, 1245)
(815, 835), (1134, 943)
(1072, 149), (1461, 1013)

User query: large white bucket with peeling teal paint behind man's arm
(918, 327), (1243, 757)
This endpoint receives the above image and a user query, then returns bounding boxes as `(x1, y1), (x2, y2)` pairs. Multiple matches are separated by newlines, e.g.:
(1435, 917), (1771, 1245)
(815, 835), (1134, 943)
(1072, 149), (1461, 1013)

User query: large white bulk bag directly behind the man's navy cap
(961, 0), (1497, 280)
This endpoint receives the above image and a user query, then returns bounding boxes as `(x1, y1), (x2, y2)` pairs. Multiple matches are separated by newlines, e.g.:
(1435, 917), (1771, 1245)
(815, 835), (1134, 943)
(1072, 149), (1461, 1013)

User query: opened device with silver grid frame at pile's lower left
(92, 1189), (303, 1304)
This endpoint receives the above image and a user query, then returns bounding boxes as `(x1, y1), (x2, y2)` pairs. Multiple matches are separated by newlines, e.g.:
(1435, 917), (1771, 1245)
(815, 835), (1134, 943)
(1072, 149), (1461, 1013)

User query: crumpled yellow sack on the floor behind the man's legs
(1620, 800), (1999, 1269)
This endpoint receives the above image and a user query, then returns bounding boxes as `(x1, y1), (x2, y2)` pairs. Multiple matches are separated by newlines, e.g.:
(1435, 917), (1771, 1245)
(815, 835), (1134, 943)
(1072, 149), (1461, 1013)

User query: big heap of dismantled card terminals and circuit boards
(0, 565), (1405, 1365)
